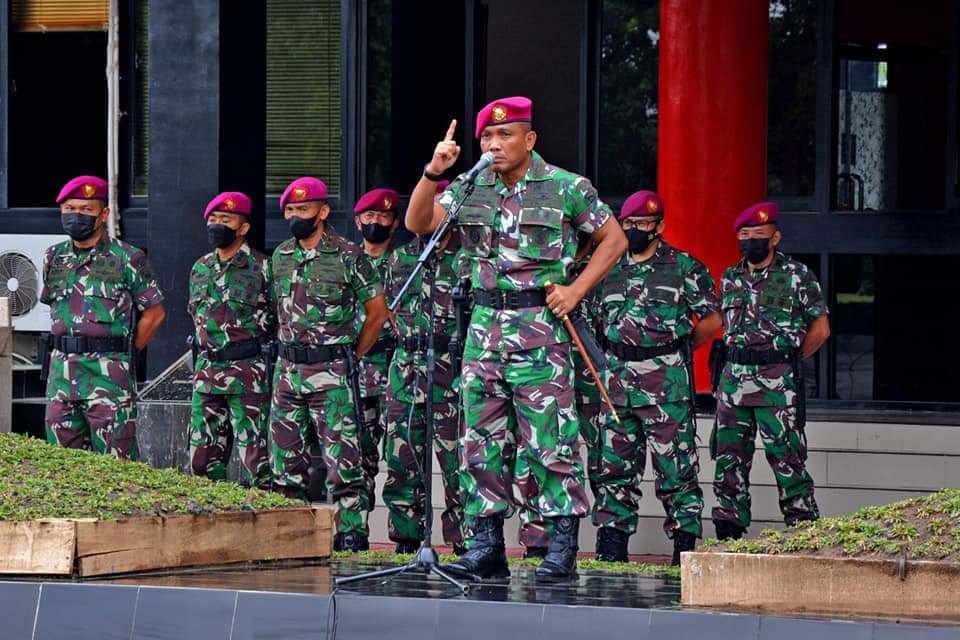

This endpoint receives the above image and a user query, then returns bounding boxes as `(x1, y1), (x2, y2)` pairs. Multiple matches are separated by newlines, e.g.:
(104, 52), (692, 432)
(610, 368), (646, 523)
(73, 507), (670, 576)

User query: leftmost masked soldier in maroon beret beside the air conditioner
(40, 176), (164, 460)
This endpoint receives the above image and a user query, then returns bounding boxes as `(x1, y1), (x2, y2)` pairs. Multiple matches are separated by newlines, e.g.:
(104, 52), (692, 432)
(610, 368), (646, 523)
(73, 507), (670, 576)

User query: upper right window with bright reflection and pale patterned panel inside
(833, 0), (954, 211)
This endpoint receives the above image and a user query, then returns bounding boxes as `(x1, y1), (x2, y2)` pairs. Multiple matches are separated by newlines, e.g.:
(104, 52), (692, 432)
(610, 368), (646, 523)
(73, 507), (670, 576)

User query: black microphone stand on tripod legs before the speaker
(334, 181), (475, 594)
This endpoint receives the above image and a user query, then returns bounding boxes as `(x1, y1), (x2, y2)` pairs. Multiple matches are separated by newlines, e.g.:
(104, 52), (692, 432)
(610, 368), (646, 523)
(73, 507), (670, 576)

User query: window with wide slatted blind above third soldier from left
(266, 0), (342, 194)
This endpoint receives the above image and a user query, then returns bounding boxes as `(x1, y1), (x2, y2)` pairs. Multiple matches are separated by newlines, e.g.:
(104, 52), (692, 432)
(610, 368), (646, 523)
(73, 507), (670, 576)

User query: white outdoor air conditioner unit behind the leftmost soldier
(0, 234), (67, 331)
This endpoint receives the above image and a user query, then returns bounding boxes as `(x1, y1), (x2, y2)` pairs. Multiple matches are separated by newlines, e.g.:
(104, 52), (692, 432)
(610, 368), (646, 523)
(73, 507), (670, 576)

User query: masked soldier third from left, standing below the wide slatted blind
(270, 178), (387, 551)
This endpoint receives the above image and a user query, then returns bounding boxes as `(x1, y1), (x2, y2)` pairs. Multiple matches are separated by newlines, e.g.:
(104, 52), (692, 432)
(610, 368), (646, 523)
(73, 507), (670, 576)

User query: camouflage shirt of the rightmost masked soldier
(718, 251), (827, 407)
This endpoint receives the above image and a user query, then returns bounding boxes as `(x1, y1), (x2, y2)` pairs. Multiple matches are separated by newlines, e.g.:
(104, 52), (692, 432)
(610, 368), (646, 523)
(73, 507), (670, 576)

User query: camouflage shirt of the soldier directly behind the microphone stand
(385, 231), (462, 404)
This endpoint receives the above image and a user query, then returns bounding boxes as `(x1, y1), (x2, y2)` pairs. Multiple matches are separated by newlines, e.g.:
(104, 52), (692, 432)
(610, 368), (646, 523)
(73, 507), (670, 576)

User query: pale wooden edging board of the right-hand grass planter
(681, 552), (960, 620)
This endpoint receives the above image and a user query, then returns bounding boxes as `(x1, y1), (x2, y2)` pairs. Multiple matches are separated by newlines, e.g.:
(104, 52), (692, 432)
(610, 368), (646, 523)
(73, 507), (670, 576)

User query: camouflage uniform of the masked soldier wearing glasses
(593, 240), (719, 537)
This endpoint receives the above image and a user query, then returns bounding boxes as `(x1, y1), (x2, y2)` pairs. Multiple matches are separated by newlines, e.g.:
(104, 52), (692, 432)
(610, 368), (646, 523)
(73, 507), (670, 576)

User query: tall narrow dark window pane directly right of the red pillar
(767, 0), (817, 198)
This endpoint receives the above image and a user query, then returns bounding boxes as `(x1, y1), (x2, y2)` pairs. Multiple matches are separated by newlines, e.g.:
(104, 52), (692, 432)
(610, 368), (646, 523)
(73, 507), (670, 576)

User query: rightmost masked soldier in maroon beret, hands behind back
(710, 202), (830, 540)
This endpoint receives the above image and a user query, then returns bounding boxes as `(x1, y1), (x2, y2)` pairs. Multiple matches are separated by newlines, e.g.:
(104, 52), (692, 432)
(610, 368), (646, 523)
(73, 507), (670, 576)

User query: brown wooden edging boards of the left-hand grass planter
(0, 507), (333, 577)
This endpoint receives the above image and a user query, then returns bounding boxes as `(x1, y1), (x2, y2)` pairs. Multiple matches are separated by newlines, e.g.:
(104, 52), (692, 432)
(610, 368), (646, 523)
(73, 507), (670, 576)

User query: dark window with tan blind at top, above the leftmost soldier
(7, 8), (107, 207)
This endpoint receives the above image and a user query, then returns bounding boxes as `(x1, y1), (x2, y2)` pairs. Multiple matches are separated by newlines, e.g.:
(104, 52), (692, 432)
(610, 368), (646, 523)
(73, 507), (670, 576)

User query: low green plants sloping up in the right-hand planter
(701, 489), (960, 562)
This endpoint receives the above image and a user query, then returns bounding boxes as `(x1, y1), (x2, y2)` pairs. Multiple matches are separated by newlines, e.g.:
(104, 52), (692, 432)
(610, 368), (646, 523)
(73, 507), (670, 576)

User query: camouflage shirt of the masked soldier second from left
(187, 243), (277, 394)
